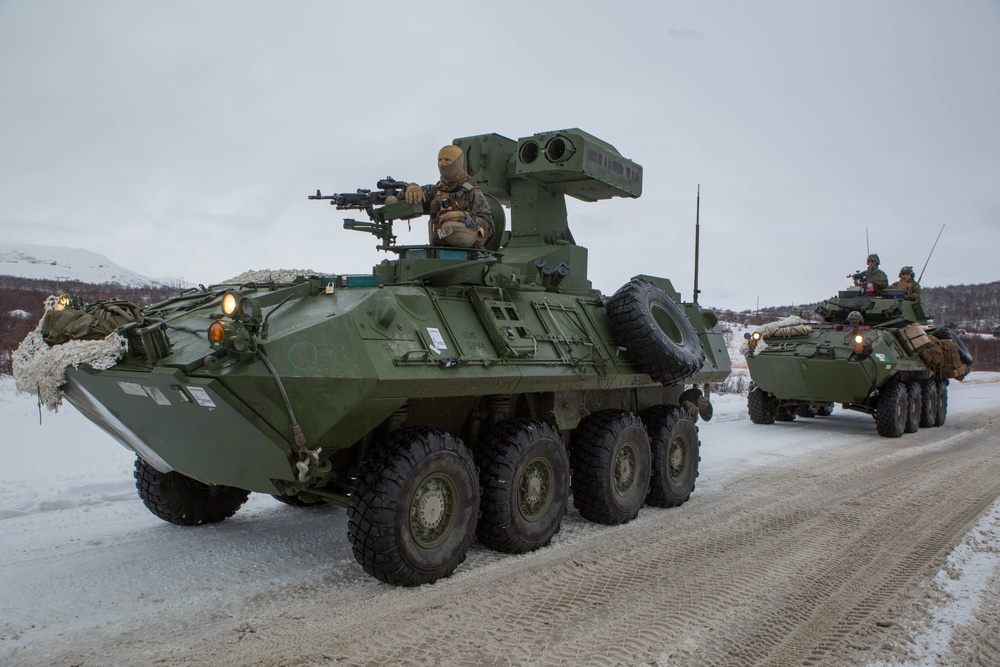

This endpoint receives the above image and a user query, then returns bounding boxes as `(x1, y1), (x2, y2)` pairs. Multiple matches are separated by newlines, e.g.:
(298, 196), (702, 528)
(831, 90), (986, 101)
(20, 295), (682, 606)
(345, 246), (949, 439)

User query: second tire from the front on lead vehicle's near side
(476, 418), (569, 554)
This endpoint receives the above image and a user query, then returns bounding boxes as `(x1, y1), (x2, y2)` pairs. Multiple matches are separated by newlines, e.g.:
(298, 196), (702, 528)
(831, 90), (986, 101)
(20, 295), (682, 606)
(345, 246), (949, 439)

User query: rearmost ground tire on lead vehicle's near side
(642, 405), (701, 507)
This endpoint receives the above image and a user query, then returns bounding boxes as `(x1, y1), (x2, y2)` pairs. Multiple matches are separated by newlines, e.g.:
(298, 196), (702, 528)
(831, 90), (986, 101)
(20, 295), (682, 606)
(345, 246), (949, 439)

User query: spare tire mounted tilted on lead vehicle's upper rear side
(607, 280), (705, 384)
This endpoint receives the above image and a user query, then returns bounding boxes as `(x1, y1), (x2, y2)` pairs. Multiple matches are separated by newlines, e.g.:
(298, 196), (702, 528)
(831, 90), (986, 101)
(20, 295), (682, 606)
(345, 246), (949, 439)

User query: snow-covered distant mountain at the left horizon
(0, 243), (188, 287)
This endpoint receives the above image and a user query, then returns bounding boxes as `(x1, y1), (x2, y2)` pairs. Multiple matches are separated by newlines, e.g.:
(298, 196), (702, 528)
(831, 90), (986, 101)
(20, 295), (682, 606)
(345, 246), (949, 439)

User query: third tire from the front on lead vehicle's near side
(569, 410), (651, 525)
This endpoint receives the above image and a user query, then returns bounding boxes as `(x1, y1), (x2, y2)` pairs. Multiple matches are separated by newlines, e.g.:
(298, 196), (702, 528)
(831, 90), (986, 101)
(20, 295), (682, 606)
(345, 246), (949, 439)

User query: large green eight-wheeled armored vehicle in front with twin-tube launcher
(23, 129), (729, 585)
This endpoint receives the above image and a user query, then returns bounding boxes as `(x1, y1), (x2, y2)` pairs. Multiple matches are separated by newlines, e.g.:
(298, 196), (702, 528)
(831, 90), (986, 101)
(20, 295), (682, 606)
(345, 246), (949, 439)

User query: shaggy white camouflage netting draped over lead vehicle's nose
(12, 296), (128, 412)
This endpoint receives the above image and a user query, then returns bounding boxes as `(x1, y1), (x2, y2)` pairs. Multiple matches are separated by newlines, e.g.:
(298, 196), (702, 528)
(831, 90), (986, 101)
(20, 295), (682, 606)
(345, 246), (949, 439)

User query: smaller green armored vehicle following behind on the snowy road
(742, 289), (972, 438)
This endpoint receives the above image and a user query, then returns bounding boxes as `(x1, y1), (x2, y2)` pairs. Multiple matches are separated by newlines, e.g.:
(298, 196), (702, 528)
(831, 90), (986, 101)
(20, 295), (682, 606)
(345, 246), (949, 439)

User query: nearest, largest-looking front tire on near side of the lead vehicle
(347, 428), (479, 586)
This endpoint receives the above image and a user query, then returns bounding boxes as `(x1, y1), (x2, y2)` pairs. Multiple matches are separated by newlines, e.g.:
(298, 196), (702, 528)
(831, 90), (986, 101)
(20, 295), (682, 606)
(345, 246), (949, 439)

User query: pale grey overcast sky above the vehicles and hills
(0, 0), (1000, 310)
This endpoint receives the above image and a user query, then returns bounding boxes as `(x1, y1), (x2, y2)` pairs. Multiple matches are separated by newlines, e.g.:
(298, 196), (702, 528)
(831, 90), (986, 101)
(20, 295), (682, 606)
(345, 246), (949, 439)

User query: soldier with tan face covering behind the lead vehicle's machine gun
(403, 146), (493, 248)
